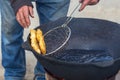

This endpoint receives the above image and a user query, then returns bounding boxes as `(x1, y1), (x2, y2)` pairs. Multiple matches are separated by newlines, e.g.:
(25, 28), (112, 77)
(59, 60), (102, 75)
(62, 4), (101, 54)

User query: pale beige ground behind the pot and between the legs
(0, 0), (120, 80)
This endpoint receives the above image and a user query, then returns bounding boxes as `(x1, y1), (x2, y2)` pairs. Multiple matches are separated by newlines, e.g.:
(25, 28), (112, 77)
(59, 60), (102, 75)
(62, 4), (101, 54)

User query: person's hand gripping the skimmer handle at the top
(79, 0), (99, 11)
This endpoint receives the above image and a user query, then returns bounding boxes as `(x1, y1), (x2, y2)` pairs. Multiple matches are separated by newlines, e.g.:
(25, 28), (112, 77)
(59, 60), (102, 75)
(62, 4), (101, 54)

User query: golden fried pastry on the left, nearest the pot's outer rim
(30, 29), (41, 54)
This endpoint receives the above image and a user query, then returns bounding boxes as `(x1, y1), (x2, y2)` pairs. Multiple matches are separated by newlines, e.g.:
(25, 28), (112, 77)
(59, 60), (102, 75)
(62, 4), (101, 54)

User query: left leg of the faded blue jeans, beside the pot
(0, 0), (26, 80)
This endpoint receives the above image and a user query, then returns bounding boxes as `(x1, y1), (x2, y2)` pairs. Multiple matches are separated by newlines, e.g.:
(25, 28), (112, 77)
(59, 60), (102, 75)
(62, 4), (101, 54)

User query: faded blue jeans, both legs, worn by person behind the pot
(0, 0), (69, 80)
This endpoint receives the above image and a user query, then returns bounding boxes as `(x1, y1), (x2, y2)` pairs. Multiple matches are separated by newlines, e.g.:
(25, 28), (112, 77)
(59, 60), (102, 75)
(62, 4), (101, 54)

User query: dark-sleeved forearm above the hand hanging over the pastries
(10, 0), (33, 14)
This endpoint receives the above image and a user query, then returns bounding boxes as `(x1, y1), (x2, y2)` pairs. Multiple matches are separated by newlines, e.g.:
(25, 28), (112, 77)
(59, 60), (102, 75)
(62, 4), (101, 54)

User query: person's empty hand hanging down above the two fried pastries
(16, 5), (34, 28)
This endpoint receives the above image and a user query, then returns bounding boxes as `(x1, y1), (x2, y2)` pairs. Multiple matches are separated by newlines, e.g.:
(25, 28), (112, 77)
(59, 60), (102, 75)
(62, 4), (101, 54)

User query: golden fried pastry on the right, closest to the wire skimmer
(37, 29), (46, 54)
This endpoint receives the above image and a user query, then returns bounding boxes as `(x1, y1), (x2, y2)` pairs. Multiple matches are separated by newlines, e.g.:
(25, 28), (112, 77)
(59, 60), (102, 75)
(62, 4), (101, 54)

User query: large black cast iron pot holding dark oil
(23, 17), (120, 80)
